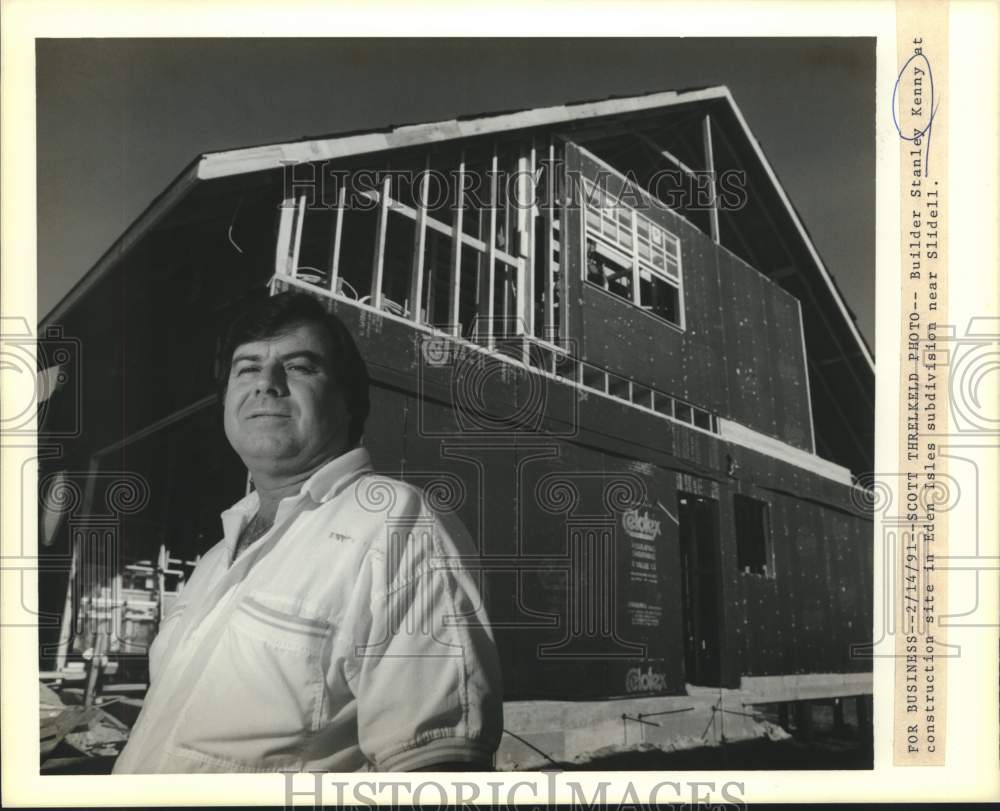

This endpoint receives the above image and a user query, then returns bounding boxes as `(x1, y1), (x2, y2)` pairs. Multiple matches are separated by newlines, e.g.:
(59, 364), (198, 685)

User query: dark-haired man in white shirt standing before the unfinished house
(115, 293), (502, 773)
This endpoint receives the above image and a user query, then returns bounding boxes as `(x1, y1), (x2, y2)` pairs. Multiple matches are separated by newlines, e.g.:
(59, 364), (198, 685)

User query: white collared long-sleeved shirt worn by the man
(114, 448), (503, 773)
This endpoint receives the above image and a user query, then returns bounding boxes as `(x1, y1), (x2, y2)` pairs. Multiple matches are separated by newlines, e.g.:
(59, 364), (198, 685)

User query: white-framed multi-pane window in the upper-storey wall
(583, 178), (684, 329)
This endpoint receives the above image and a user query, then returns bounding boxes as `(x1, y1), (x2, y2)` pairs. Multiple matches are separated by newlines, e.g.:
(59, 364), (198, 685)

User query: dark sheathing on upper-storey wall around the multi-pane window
(565, 147), (811, 450)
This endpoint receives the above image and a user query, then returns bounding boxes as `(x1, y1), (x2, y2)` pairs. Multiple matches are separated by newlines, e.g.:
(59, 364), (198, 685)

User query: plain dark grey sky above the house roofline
(36, 37), (876, 347)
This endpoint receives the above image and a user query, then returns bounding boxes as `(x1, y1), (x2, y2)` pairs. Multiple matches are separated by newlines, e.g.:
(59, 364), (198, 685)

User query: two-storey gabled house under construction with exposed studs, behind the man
(39, 87), (874, 766)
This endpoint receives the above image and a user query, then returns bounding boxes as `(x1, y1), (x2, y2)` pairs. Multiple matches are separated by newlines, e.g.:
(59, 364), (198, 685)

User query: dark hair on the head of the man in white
(218, 291), (370, 447)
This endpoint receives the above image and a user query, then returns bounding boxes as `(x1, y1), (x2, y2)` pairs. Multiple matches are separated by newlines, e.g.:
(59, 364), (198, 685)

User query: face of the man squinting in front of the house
(225, 324), (350, 477)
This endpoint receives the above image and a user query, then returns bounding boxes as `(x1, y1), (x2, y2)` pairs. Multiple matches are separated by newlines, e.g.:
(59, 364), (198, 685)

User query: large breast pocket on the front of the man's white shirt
(178, 593), (333, 771)
